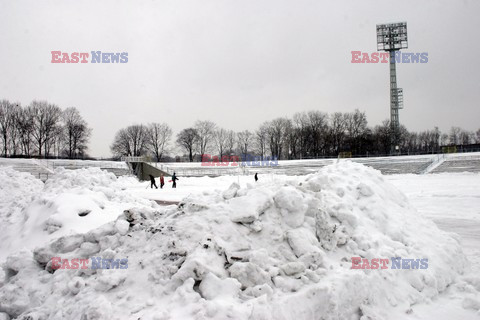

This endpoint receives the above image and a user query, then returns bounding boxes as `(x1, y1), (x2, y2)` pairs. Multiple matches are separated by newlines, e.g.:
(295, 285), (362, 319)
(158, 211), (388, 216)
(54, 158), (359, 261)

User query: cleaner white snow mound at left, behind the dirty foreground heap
(0, 168), (156, 261)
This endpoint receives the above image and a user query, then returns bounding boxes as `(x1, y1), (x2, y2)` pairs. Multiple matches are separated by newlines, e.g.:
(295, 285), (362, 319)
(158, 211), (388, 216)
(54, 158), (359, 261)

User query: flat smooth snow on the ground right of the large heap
(387, 172), (480, 319)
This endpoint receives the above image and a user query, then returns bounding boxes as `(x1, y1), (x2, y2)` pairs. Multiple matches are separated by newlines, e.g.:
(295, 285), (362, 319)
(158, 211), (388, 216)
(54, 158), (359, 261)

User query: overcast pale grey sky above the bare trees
(0, 0), (480, 156)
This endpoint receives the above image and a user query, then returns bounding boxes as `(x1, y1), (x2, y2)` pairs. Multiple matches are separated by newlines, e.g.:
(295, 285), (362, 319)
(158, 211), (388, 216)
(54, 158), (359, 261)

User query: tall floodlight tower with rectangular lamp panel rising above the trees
(377, 22), (408, 153)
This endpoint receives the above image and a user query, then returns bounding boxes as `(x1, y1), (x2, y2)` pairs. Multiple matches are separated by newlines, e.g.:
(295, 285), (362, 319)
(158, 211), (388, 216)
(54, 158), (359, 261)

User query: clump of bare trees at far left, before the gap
(0, 99), (91, 159)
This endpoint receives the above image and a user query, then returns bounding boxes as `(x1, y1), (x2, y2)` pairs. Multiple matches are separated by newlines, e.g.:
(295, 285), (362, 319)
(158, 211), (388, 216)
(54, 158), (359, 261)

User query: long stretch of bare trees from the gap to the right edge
(111, 110), (480, 161)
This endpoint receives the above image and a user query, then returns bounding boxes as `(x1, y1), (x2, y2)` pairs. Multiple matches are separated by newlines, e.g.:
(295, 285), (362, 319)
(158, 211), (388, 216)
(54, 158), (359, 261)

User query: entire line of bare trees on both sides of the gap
(0, 99), (480, 161)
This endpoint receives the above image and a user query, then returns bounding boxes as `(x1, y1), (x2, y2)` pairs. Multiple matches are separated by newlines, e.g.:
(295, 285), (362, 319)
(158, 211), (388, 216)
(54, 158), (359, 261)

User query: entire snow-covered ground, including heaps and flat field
(0, 161), (480, 319)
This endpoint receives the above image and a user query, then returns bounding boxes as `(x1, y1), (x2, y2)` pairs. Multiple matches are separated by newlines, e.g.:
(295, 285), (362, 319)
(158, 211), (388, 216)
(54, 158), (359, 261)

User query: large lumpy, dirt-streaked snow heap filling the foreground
(0, 162), (479, 319)
